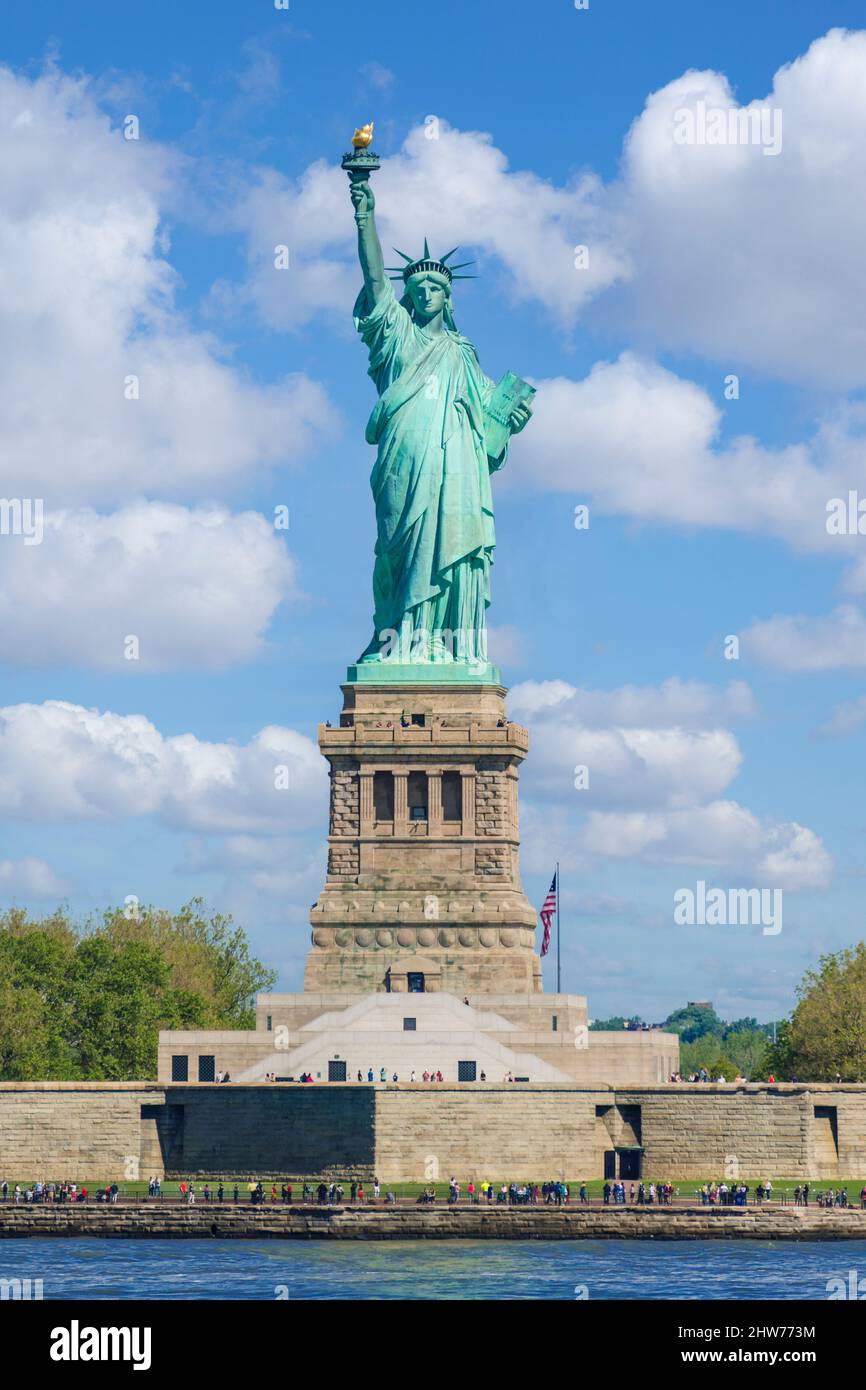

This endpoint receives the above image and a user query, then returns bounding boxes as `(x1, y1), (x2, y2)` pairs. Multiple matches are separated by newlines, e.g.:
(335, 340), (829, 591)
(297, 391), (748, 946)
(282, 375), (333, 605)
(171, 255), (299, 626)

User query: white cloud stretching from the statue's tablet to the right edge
(500, 352), (866, 564)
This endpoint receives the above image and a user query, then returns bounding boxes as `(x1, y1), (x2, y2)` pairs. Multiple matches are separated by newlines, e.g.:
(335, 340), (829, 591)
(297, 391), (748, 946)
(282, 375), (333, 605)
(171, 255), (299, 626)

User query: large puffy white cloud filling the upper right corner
(609, 29), (866, 388)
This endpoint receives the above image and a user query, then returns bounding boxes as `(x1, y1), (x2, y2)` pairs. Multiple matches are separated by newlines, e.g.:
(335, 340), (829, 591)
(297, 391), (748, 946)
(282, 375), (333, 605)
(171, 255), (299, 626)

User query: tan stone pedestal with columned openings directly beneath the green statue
(304, 671), (542, 997)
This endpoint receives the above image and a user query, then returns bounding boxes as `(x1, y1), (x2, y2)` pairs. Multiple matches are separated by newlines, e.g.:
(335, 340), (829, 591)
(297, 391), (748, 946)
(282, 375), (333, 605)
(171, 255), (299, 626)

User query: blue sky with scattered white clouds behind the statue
(0, 0), (866, 1019)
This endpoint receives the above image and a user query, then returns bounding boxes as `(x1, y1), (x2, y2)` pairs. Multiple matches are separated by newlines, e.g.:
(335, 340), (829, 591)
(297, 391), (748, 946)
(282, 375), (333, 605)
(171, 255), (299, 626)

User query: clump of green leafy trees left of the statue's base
(0, 899), (275, 1081)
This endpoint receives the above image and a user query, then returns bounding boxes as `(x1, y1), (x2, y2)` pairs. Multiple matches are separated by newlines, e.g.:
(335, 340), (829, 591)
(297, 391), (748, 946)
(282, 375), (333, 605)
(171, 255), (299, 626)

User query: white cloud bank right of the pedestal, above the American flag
(510, 680), (833, 888)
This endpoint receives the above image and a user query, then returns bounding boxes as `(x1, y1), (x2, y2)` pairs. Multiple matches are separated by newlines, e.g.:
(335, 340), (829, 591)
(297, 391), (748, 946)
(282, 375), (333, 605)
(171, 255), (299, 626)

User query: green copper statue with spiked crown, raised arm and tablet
(343, 157), (532, 678)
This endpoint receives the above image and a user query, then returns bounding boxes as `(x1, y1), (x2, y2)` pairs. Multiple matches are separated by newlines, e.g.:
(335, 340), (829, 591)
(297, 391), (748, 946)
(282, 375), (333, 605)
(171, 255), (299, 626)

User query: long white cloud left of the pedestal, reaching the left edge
(0, 701), (327, 834)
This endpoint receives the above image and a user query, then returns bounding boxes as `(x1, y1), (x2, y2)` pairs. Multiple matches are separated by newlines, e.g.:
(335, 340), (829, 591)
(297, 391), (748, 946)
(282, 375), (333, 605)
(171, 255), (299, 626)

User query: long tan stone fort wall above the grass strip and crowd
(0, 1081), (866, 1182)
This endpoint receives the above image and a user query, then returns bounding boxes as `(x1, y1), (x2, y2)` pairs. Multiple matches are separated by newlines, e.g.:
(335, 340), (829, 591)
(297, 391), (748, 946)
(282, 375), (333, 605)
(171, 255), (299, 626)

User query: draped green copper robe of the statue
(354, 285), (507, 662)
